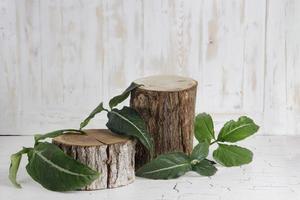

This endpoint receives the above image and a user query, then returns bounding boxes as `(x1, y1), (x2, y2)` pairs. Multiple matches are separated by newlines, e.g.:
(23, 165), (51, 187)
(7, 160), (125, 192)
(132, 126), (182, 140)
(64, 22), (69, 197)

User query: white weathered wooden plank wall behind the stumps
(0, 0), (300, 134)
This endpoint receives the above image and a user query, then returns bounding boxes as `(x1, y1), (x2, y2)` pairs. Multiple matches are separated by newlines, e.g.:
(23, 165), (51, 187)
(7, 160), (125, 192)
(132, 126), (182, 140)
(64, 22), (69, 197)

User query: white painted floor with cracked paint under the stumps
(0, 135), (300, 200)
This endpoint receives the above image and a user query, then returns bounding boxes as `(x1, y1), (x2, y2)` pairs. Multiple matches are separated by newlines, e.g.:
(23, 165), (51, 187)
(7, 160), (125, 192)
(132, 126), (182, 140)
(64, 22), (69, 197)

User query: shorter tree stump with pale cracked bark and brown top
(52, 129), (136, 190)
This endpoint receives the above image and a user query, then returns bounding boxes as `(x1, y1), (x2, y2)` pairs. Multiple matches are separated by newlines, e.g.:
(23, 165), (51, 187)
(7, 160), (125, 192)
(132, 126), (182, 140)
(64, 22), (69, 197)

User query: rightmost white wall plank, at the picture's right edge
(263, 0), (300, 134)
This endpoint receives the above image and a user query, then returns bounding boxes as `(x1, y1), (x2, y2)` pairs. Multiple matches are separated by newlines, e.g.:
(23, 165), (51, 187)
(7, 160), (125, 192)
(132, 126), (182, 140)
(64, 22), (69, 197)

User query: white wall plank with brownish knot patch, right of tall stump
(202, 0), (243, 113)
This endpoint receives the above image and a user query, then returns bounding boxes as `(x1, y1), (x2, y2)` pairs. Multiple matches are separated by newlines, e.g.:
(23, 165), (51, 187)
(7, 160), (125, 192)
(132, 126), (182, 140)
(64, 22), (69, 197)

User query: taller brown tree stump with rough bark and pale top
(130, 76), (197, 169)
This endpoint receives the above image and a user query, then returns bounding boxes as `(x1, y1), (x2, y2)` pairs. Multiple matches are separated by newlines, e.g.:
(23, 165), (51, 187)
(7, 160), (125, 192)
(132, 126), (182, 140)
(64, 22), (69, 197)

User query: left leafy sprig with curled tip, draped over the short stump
(9, 129), (100, 191)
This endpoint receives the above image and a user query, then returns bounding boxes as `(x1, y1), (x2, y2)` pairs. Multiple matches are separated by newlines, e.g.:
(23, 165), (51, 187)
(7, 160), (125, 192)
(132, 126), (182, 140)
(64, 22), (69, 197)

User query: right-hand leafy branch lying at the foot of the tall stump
(136, 113), (259, 179)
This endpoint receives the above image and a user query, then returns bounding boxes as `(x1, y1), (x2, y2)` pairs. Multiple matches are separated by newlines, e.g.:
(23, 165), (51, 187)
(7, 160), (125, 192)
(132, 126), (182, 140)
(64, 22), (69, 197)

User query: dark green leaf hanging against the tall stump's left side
(106, 106), (154, 156)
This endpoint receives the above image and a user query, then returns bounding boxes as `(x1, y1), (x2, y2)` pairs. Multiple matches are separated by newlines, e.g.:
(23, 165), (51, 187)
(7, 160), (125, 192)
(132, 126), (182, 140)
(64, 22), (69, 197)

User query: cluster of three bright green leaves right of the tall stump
(194, 113), (259, 167)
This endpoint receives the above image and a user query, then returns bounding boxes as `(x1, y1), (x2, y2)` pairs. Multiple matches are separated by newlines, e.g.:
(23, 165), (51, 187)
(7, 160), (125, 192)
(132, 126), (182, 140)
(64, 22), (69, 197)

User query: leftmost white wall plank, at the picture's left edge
(0, 0), (41, 134)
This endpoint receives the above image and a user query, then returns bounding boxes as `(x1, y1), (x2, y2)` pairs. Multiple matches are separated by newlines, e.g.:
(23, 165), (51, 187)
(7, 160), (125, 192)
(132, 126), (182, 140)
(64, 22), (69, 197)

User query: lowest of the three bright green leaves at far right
(213, 144), (253, 167)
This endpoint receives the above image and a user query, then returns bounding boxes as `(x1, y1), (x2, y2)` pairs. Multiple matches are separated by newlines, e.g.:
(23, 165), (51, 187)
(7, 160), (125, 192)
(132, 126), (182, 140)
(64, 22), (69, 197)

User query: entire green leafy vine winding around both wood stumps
(9, 79), (259, 188)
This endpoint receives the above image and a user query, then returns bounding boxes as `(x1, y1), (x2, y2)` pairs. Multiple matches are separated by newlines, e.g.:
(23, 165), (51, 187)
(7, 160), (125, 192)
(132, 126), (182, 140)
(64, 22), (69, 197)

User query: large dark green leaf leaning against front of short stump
(26, 142), (99, 191)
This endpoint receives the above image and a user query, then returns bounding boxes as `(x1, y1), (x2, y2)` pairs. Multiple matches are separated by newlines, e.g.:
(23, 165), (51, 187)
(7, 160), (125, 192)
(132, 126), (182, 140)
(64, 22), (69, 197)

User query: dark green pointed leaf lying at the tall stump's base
(136, 152), (191, 179)
